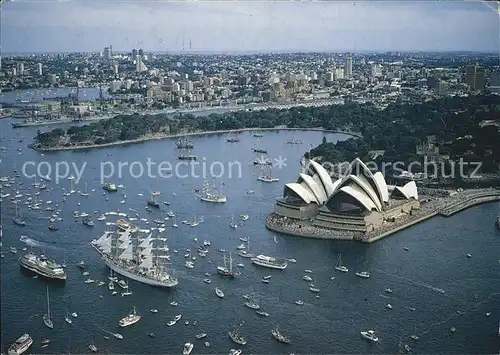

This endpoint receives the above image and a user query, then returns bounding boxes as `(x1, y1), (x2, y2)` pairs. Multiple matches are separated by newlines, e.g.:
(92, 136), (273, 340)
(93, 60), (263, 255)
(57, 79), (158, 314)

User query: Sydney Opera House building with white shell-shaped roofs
(266, 158), (420, 239)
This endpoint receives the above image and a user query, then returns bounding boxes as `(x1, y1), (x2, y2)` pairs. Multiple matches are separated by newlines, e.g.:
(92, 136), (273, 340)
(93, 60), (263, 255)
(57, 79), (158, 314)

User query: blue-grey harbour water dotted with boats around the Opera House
(0, 119), (500, 354)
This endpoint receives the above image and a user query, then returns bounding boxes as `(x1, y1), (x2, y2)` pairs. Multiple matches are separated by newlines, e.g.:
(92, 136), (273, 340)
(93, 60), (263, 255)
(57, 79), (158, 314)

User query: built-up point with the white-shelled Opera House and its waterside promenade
(266, 158), (500, 243)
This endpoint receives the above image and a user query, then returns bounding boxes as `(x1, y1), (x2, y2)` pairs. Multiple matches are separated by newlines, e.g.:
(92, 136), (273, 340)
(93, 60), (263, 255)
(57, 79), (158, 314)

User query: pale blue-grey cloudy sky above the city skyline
(1, 0), (500, 53)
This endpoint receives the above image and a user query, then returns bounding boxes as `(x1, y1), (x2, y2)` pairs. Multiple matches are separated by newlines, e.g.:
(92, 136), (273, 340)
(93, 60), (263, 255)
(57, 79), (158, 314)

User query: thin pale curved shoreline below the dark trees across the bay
(30, 127), (361, 152)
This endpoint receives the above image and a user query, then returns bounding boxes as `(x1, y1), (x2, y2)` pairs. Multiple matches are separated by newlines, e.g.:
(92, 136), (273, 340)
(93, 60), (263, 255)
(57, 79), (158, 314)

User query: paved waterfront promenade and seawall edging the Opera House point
(265, 189), (500, 243)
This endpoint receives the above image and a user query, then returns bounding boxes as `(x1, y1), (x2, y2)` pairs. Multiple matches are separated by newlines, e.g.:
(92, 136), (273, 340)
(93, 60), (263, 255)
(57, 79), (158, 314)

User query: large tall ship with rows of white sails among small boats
(91, 227), (179, 287)
